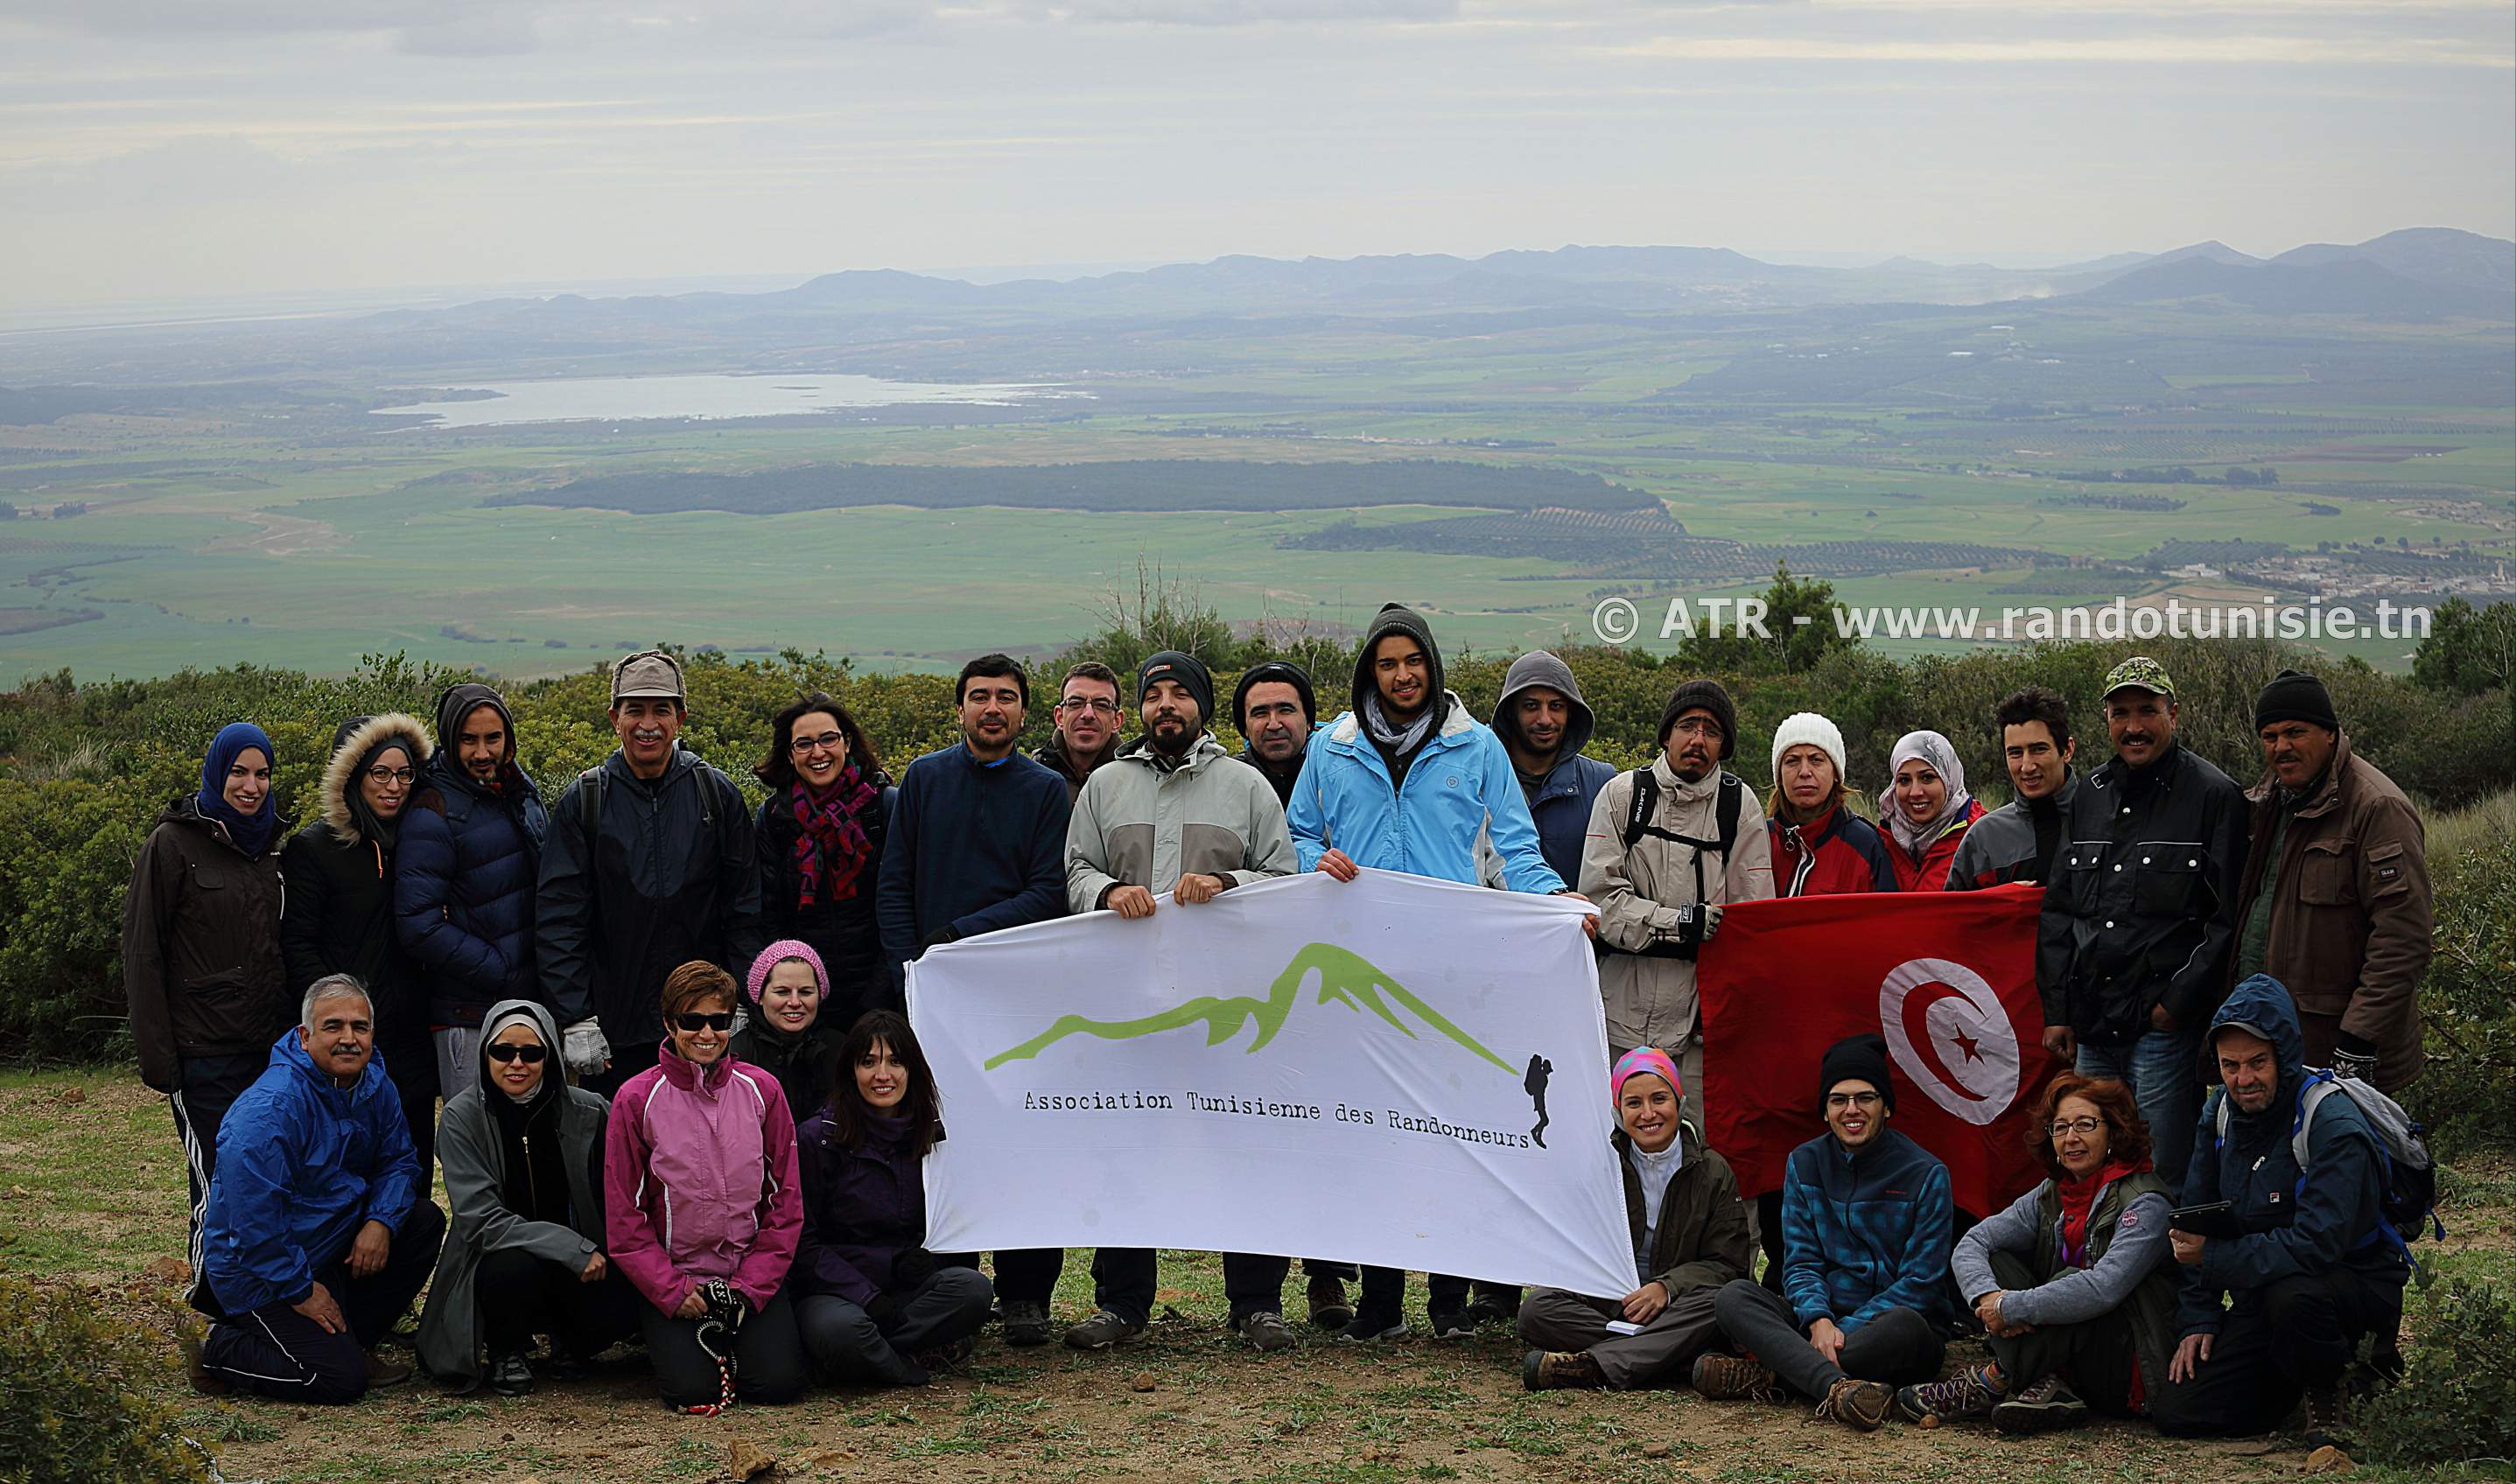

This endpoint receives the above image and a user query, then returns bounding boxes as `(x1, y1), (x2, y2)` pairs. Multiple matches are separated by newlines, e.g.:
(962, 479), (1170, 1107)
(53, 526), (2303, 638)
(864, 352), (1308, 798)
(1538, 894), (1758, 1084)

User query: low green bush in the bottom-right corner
(2350, 1278), (2516, 1469)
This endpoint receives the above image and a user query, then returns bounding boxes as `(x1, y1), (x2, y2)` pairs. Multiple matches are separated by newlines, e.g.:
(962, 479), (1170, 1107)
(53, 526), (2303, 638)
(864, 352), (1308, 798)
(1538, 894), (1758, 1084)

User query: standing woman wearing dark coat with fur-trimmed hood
(279, 712), (438, 1174)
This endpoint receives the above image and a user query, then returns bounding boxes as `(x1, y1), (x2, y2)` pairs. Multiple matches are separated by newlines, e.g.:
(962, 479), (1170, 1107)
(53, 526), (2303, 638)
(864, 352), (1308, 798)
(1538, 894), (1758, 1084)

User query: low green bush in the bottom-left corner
(0, 1278), (209, 1484)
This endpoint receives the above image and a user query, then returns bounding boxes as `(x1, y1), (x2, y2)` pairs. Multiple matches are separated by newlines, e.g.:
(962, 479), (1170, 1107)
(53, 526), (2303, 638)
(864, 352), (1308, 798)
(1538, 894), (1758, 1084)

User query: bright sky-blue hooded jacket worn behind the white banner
(1286, 604), (1570, 892)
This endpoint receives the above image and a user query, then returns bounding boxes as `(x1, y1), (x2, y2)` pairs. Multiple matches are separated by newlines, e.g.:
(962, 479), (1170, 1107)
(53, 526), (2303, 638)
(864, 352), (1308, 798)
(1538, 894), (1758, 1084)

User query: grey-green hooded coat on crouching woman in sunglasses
(417, 998), (612, 1391)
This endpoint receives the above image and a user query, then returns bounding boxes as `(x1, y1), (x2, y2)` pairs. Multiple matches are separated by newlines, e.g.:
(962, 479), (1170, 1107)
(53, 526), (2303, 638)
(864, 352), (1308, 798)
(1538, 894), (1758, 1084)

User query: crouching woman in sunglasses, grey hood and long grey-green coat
(420, 998), (639, 1396)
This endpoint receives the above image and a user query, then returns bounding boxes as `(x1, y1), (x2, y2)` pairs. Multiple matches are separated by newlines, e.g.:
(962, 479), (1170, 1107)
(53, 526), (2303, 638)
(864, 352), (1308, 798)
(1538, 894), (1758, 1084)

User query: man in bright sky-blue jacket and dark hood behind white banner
(1286, 604), (1573, 1340)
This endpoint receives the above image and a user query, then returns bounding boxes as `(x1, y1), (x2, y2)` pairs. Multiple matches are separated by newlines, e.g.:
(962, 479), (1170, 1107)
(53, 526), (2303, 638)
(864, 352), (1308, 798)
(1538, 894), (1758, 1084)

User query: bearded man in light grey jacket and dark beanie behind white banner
(1067, 649), (1293, 1351)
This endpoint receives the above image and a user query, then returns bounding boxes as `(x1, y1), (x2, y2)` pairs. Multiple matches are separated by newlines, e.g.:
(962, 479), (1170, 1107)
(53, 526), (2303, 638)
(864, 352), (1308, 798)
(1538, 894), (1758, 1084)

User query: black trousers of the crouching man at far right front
(2148, 1268), (2403, 1438)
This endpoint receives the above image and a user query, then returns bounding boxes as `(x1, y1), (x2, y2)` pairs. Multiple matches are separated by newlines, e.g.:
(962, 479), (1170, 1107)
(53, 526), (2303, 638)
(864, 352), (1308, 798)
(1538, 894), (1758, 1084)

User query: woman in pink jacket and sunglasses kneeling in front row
(604, 963), (805, 1414)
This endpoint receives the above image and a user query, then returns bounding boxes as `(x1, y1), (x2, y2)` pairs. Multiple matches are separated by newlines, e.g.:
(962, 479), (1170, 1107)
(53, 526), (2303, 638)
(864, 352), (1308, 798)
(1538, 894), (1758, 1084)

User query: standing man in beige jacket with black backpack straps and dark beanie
(1580, 679), (1774, 1127)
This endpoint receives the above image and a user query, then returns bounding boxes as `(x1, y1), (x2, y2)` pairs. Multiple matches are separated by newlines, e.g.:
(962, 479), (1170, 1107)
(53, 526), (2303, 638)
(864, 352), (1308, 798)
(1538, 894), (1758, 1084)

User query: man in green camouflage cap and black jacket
(2036, 654), (2246, 1190)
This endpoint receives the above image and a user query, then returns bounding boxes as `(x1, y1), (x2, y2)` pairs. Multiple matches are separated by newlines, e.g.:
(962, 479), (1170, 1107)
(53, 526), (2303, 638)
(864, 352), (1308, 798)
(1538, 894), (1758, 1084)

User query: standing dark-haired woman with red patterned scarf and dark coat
(753, 692), (901, 1036)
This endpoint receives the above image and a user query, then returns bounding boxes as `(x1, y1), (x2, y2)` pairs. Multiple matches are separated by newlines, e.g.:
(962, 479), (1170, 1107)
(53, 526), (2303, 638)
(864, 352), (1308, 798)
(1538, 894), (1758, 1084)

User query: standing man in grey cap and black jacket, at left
(534, 649), (762, 1096)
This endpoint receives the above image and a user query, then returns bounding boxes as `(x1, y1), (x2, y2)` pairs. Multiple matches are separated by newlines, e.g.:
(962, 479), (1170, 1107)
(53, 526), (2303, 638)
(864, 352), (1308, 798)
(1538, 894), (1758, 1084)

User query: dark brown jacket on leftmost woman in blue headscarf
(123, 794), (297, 1092)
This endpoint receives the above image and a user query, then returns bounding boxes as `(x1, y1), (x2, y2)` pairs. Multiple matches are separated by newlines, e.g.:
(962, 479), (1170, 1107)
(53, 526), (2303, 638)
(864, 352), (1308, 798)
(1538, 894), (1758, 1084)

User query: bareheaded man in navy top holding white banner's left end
(873, 654), (1072, 1346)
